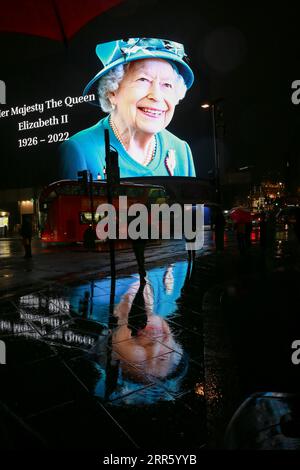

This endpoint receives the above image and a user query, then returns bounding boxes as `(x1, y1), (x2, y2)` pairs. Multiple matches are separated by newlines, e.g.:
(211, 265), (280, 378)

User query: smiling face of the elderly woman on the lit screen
(110, 59), (178, 134)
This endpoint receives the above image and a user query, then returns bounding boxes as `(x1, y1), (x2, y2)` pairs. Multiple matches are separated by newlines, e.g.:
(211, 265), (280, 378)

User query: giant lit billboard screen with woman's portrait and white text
(0, 25), (199, 188)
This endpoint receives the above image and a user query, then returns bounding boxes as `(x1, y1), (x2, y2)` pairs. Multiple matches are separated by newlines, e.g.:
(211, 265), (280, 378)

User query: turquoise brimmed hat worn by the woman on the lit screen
(83, 38), (194, 96)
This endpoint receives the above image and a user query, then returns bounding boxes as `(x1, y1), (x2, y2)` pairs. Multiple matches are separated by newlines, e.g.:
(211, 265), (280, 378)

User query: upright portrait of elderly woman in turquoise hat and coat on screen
(60, 38), (195, 179)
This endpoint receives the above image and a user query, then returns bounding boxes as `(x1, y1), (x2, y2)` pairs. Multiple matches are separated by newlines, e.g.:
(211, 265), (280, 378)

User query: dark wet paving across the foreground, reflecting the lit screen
(0, 232), (300, 451)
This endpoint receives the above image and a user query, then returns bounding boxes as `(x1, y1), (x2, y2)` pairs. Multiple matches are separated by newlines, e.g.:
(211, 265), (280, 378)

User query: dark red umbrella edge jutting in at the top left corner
(0, 0), (124, 42)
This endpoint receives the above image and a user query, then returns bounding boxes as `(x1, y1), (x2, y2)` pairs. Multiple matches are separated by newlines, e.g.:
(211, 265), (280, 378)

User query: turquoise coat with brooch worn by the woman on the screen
(59, 117), (196, 179)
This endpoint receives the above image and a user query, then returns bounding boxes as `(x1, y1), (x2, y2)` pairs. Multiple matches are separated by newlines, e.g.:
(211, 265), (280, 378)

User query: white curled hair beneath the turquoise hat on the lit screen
(98, 62), (187, 113)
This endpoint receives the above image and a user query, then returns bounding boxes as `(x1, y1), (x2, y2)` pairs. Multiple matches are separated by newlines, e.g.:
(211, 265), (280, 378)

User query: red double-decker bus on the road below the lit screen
(39, 180), (167, 244)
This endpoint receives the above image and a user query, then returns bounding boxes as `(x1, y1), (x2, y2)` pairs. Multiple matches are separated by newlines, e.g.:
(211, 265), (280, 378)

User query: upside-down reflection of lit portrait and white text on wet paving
(0, 261), (203, 407)
